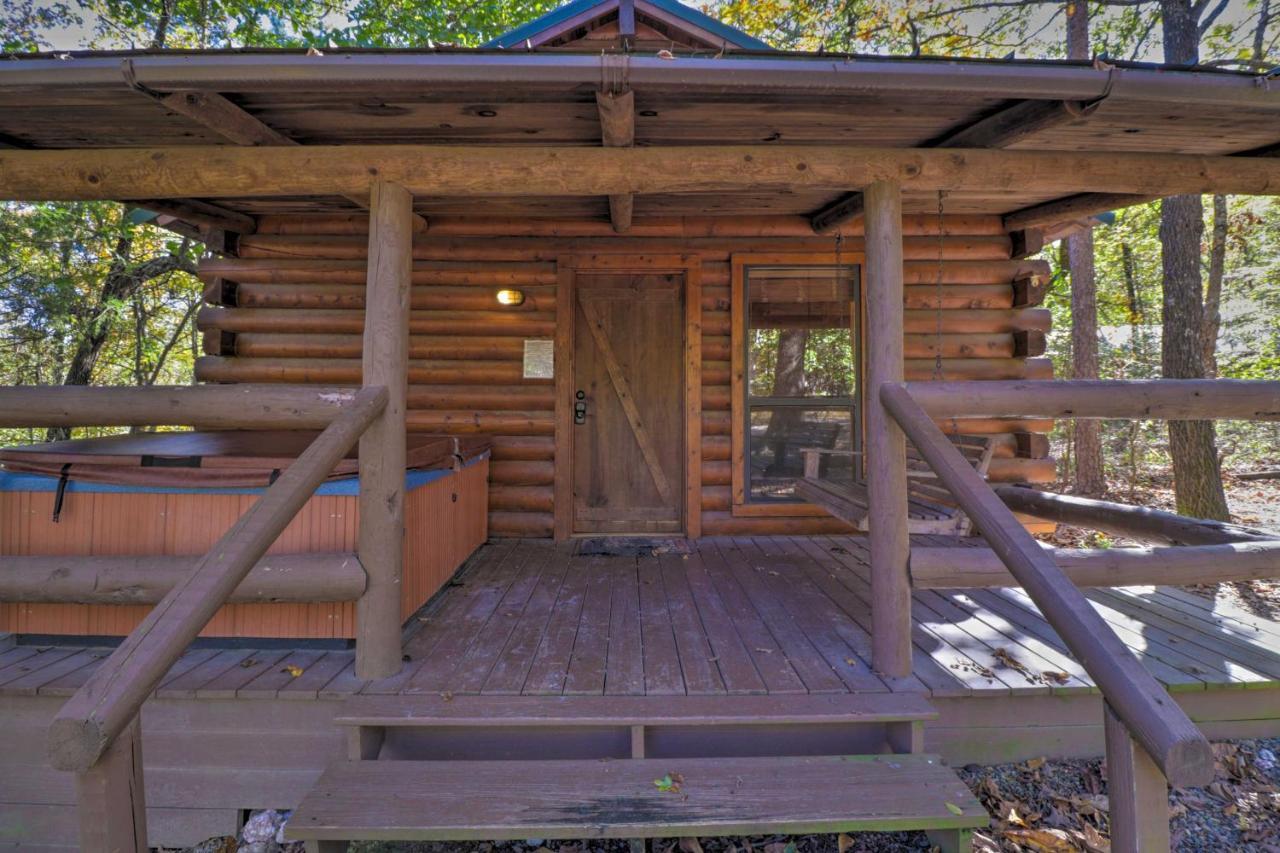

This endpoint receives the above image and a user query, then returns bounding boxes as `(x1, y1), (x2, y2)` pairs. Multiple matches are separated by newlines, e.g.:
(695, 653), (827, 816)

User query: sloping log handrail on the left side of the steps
(49, 388), (384, 771)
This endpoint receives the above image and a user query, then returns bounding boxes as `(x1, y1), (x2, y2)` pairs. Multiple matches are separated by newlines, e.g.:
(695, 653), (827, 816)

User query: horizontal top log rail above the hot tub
(0, 384), (356, 429)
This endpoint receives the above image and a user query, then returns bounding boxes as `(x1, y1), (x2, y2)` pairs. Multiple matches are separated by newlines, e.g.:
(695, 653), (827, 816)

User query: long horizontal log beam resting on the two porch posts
(0, 145), (1280, 201)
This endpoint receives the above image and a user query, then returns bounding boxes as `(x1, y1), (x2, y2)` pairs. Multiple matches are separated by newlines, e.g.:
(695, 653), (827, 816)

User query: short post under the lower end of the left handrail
(76, 715), (148, 853)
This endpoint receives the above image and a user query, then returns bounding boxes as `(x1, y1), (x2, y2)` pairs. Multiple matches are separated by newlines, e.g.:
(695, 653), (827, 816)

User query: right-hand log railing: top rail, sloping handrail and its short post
(878, 380), (1280, 852)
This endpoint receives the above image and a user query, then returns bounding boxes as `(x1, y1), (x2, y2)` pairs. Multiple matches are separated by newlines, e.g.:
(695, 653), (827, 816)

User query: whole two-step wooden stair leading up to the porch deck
(287, 694), (988, 850)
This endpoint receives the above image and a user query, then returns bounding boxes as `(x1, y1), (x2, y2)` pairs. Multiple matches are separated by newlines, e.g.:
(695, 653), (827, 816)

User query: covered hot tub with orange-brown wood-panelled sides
(0, 430), (489, 639)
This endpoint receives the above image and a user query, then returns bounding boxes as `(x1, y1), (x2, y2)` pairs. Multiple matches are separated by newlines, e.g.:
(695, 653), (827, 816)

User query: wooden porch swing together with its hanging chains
(795, 191), (995, 535)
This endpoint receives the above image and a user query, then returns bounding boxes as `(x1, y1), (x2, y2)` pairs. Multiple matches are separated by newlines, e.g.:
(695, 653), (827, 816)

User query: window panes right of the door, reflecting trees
(735, 264), (861, 505)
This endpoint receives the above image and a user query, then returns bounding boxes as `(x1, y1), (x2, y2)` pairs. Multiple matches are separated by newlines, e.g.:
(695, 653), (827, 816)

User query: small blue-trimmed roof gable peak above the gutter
(485, 0), (772, 53)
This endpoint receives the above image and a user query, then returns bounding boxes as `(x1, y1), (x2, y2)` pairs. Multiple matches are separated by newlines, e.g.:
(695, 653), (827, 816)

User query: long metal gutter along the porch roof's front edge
(0, 53), (1280, 108)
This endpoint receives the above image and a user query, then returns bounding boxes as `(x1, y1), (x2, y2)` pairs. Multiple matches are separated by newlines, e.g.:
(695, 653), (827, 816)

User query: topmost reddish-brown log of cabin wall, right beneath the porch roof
(257, 214), (1005, 237)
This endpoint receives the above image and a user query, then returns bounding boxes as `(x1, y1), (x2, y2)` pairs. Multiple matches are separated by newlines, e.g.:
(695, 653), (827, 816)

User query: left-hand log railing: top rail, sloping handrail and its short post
(0, 386), (388, 850)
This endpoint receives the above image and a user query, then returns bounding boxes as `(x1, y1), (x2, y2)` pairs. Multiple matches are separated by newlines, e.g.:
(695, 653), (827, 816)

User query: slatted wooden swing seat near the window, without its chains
(795, 435), (995, 535)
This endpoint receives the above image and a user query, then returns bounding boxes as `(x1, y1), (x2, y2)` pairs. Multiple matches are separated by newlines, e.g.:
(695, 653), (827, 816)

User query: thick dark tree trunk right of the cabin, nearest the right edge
(1160, 0), (1230, 521)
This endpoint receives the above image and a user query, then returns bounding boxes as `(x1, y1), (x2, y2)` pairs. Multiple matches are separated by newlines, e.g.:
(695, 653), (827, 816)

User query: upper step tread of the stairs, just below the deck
(334, 693), (938, 727)
